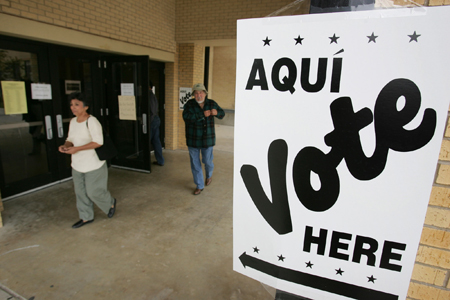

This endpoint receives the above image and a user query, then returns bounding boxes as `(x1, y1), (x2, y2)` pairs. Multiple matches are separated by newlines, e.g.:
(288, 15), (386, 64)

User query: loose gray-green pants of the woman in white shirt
(72, 163), (114, 221)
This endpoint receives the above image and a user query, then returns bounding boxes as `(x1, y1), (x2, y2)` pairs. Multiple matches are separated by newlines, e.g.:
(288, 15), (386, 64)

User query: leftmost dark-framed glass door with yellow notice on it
(0, 40), (58, 198)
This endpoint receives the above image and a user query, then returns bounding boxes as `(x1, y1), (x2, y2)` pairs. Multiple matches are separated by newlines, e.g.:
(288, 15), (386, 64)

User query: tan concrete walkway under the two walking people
(0, 141), (275, 300)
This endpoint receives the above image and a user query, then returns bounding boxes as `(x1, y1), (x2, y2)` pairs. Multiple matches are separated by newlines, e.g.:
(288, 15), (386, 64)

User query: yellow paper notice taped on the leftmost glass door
(2, 81), (28, 115)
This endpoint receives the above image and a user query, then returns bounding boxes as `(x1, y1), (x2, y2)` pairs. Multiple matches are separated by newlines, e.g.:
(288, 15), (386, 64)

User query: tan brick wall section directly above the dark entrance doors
(0, 0), (175, 52)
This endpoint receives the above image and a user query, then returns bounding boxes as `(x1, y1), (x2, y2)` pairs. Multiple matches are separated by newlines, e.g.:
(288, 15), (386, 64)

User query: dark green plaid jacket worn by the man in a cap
(183, 98), (225, 148)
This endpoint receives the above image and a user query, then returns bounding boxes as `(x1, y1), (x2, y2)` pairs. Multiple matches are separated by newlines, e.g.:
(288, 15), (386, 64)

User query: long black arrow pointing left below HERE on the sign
(239, 252), (398, 300)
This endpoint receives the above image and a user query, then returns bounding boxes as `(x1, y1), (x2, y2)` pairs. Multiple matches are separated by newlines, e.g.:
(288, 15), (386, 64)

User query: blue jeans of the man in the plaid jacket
(188, 147), (214, 190)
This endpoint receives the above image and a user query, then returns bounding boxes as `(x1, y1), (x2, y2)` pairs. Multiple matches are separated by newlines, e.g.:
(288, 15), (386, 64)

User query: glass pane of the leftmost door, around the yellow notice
(0, 49), (49, 184)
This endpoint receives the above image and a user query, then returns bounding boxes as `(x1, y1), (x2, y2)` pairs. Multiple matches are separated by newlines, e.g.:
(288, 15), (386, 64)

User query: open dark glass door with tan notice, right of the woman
(103, 56), (151, 172)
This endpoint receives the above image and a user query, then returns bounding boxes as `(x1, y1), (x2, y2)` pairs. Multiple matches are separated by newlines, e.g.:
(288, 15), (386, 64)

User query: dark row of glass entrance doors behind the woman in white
(0, 36), (164, 199)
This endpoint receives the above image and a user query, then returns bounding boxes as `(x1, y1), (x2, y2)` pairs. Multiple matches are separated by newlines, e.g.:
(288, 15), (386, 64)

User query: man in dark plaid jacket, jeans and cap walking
(183, 83), (225, 195)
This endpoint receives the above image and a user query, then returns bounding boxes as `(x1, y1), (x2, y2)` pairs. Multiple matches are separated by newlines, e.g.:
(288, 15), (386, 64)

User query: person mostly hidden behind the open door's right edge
(148, 81), (164, 167)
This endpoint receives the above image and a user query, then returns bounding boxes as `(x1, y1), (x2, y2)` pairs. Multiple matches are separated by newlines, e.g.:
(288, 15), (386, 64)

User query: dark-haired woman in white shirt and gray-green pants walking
(58, 92), (116, 228)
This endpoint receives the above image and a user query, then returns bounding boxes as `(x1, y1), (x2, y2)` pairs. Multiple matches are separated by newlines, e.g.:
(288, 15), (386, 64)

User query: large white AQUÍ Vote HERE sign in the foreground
(233, 7), (450, 300)
